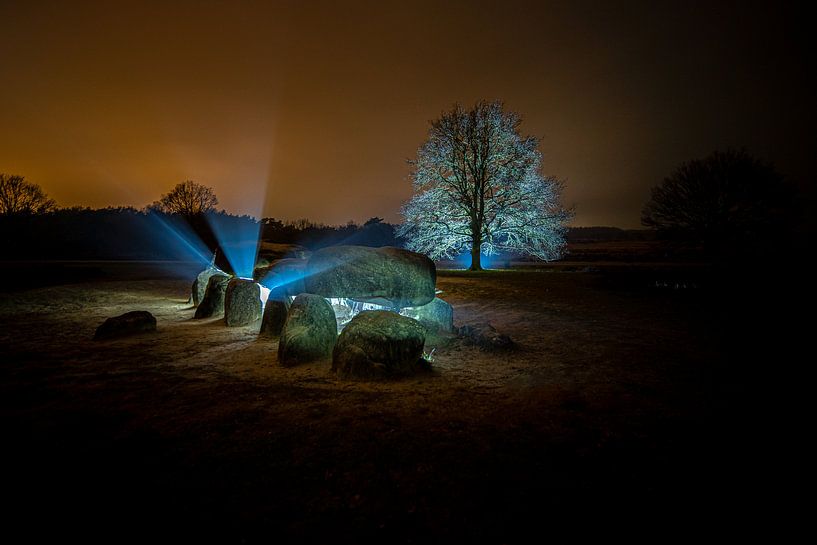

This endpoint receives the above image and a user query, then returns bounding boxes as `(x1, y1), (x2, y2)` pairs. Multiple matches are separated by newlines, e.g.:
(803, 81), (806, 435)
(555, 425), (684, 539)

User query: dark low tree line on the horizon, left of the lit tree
(0, 207), (401, 260)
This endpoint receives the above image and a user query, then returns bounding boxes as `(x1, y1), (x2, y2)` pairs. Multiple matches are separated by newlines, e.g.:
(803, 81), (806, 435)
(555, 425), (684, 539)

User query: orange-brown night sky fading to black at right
(0, 0), (817, 227)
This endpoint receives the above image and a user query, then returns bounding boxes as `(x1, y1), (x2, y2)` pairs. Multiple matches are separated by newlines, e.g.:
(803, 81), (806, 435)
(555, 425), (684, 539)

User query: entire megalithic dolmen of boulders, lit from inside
(193, 246), (454, 380)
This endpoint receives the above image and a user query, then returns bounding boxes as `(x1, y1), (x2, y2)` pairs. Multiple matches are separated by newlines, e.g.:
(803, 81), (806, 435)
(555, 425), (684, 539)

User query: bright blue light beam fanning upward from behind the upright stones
(207, 213), (261, 278)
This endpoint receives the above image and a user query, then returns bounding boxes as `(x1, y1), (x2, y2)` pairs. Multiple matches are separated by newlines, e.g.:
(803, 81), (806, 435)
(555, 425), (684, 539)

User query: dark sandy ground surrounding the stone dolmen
(0, 267), (792, 543)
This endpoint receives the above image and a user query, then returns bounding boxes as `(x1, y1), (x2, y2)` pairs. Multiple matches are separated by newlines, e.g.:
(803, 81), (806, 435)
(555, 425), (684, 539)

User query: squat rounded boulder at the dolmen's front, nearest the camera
(332, 310), (429, 379)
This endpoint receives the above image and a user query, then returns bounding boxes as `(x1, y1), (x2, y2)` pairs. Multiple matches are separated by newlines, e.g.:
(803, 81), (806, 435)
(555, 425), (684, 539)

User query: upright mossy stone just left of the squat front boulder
(278, 293), (338, 367)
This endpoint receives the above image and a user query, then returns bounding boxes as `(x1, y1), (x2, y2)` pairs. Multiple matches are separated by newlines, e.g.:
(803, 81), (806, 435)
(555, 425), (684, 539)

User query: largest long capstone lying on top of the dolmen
(304, 246), (437, 308)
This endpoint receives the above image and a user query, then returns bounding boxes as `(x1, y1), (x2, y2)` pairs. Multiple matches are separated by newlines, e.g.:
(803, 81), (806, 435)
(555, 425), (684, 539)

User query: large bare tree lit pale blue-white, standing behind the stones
(398, 102), (571, 270)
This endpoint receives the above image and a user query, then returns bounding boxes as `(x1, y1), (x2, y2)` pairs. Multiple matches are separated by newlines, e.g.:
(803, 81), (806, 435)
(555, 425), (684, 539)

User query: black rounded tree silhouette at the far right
(641, 149), (791, 255)
